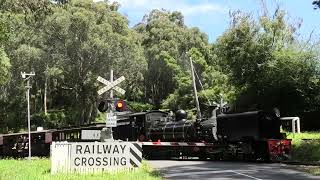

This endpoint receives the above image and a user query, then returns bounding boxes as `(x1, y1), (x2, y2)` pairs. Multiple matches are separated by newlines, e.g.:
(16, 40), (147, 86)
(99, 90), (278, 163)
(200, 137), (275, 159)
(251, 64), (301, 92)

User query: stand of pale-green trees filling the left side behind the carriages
(0, 0), (146, 131)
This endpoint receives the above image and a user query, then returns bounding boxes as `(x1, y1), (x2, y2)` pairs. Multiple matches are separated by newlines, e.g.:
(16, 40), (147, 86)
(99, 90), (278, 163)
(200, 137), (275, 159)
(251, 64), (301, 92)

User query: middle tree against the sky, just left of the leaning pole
(135, 10), (209, 108)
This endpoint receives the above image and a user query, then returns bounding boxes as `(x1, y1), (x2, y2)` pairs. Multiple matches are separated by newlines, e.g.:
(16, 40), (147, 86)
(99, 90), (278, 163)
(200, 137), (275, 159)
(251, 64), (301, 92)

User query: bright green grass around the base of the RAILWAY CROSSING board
(0, 159), (162, 180)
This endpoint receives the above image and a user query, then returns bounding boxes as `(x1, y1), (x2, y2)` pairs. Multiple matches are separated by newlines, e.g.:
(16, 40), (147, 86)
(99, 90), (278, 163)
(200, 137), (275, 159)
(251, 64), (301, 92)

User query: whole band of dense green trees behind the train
(0, 0), (320, 132)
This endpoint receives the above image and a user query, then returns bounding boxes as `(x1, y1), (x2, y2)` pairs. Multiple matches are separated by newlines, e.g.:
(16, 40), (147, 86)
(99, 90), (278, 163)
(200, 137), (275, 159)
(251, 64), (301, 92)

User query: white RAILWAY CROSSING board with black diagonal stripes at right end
(51, 141), (142, 174)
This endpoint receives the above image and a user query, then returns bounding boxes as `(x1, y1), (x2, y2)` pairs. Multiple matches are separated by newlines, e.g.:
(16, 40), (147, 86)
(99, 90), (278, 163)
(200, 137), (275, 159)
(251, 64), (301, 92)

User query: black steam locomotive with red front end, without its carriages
(114, 108), (291, 161)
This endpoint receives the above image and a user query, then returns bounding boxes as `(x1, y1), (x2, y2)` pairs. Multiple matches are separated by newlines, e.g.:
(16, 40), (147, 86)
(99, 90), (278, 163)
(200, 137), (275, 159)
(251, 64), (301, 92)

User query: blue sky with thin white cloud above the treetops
(109, 0), (320, 42)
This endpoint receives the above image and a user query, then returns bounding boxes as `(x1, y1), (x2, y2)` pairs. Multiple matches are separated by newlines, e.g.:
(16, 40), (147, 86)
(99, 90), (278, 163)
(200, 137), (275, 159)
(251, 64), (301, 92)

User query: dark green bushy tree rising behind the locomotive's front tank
(214, 9), (320, 115)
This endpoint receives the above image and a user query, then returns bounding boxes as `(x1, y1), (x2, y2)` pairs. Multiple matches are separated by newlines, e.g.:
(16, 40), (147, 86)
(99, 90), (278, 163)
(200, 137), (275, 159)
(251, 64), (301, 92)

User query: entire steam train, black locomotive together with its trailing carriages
(0, 108), (291, 161)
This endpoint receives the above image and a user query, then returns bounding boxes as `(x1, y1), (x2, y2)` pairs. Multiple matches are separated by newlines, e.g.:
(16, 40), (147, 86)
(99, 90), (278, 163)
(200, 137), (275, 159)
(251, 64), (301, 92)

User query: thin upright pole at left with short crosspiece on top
(21, 72), (35, 160)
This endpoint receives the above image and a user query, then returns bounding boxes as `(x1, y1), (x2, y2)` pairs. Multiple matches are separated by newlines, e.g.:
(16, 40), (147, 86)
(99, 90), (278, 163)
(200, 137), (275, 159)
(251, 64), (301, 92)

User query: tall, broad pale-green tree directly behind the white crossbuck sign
(43, 1), (145, 124)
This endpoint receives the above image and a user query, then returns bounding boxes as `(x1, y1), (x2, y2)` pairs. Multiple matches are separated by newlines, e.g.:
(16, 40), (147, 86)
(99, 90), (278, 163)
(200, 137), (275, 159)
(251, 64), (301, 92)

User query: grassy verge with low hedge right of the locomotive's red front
(288, 132), (320, 176)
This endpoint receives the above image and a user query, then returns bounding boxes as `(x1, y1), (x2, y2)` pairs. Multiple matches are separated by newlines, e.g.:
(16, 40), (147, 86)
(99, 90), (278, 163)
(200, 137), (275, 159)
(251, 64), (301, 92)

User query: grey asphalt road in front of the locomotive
(148, 160), (320, 180)
